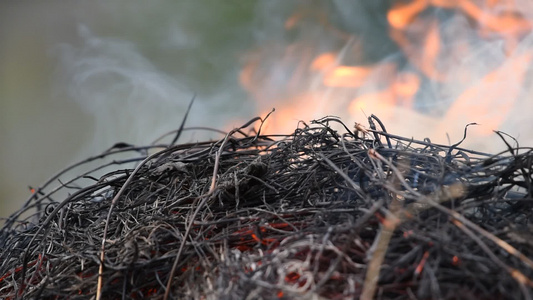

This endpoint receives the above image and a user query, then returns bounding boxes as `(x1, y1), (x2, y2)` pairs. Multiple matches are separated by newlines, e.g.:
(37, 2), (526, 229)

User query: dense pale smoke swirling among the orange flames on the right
(247, 0), (533, 151)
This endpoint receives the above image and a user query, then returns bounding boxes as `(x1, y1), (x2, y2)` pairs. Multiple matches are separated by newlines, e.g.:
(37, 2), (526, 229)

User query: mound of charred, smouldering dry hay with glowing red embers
(0, 116), (533, 299)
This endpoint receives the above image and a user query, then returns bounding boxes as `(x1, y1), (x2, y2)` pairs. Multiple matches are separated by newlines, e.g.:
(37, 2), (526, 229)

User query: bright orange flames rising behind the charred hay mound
(240, 0), (533, 149)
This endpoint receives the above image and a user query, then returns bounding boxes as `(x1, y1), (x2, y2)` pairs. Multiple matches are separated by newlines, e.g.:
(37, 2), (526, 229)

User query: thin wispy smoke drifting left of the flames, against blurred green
(54, 26), (214, 149)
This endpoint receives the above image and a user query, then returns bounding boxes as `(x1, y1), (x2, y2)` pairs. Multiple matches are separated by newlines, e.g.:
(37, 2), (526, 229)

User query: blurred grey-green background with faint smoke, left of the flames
(0, 0), (266, 217)
